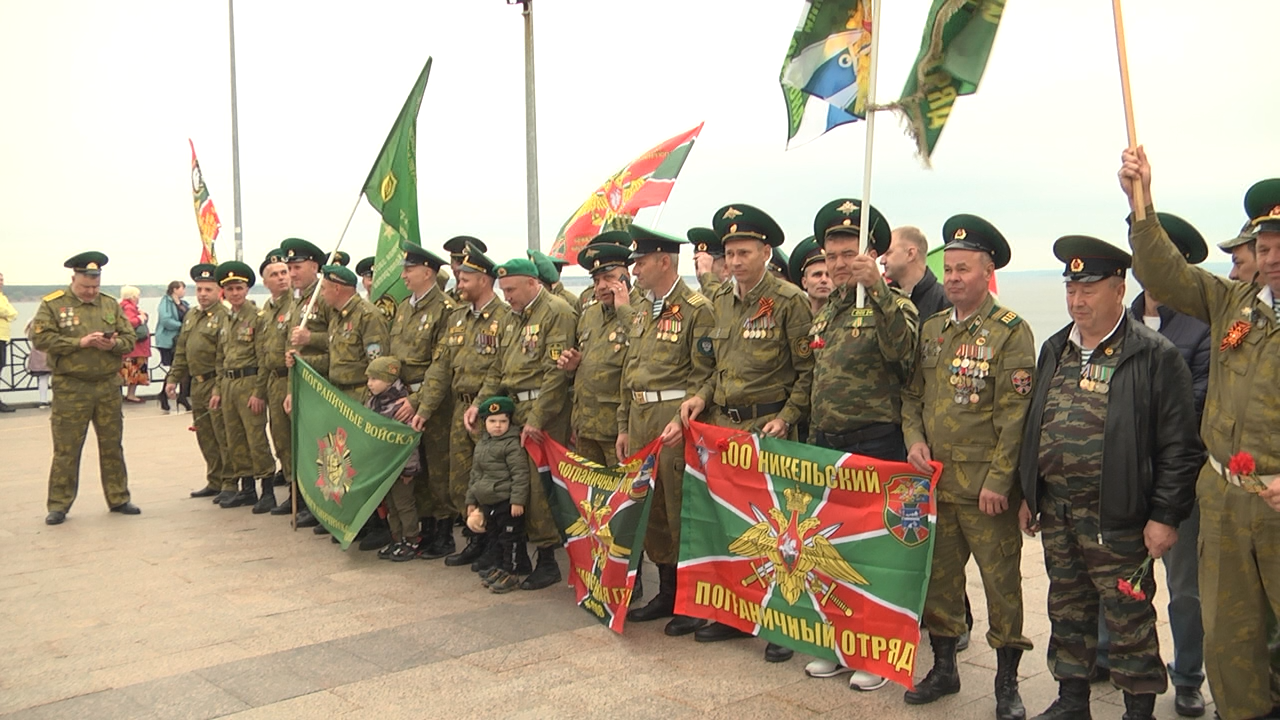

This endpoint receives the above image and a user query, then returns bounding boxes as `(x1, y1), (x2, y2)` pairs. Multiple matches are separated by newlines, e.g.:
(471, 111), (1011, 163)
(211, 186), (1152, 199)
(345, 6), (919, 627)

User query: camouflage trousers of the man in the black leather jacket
(1041, 498), (1172, 697)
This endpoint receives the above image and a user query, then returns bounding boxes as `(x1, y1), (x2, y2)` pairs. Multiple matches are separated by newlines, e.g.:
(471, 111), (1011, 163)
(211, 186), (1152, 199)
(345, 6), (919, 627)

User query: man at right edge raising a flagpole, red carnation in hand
(1112, 147), (1280, 720)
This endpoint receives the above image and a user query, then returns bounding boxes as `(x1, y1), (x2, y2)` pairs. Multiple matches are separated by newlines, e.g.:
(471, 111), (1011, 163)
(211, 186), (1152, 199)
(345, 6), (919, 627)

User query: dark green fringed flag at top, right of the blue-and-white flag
(893, 0), (1005, 163)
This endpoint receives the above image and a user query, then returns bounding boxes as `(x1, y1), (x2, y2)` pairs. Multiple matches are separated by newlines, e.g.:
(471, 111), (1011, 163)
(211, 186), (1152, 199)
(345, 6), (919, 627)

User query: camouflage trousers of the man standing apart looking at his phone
(47, 375), (129, 512)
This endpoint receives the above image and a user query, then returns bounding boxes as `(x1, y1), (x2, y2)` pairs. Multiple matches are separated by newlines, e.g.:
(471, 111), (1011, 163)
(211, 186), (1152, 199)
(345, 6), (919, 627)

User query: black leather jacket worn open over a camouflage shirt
(1019, 316), (1204, 530)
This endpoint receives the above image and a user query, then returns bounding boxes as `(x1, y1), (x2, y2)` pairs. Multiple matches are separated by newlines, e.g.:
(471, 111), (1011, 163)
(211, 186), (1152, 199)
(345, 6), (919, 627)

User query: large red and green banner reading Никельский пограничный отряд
(676, 423), (942, 688)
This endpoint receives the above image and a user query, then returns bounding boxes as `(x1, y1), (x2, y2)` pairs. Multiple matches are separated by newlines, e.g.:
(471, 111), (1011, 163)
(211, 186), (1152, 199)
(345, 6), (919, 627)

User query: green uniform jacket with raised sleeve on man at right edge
(1129, 206), (1280, 475)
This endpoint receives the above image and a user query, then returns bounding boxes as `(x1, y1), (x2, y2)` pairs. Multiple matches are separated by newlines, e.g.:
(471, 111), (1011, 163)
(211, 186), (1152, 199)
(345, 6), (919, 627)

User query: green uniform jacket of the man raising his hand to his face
(572, 301), (630, 441)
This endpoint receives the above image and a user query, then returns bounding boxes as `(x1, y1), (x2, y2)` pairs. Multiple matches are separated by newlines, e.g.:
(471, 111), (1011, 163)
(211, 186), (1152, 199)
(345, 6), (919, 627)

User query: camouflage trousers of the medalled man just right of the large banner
(924, 502), (1032, 651)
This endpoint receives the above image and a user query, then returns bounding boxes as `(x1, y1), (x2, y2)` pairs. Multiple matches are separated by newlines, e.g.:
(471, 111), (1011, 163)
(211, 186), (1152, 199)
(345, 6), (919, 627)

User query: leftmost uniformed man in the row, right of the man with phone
(164, 263), (236, 502)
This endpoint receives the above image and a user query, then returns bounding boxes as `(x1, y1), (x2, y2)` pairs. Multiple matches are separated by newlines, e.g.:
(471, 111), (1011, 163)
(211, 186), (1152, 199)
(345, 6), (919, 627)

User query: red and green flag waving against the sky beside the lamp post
(549, 123), (703, 264)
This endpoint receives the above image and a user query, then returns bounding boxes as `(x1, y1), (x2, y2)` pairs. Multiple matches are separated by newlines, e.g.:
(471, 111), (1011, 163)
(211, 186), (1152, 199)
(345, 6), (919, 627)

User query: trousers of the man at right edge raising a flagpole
(1196, 465), (1280, 720)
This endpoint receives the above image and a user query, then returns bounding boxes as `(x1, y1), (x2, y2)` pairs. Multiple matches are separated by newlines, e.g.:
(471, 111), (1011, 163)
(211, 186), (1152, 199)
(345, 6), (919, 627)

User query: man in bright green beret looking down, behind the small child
(462, 258), (576, 591)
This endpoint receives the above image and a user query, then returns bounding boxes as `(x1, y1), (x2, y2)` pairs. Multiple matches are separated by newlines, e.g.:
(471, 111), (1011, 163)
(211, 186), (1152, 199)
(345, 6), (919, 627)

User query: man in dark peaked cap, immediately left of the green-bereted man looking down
(408, 246), (511, 571)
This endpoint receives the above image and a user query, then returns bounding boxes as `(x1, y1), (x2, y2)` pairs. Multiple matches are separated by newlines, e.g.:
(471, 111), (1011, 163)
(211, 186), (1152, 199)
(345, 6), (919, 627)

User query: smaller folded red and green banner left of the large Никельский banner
(526, 430), (662, 633)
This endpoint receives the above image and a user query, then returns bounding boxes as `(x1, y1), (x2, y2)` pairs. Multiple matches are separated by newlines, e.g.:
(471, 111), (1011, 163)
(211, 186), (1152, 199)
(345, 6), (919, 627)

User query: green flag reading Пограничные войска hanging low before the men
(289, 357), (421, 550)
